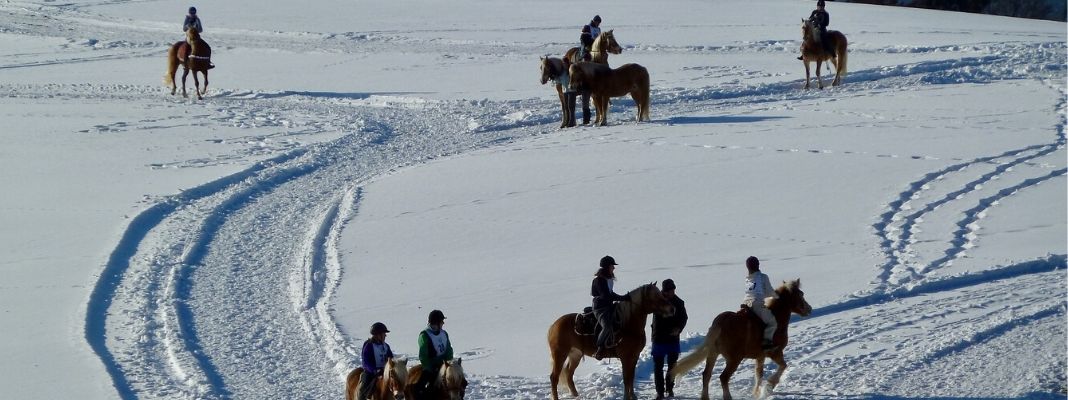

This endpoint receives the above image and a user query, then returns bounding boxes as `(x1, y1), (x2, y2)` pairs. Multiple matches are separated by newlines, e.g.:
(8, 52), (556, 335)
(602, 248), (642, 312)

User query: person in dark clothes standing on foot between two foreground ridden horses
(653, 279), (689, 400)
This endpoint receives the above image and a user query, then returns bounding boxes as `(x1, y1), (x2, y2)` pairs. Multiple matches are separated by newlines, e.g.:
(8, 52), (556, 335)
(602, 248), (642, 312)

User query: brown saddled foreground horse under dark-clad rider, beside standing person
(549, 284), (675, 400)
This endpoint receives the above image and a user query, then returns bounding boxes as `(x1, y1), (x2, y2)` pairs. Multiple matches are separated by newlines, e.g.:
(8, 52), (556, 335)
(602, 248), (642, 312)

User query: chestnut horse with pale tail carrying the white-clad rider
(673, 279), (812, 400)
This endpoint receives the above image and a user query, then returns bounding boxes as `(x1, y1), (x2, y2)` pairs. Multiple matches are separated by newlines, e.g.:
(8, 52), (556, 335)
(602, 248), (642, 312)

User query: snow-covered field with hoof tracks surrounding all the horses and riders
(0, 0), (1068, 399)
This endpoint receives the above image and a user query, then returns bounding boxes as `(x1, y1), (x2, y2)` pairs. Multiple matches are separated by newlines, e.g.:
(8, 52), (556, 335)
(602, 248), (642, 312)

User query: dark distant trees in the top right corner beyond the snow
(832, 0), (1068, 21)
